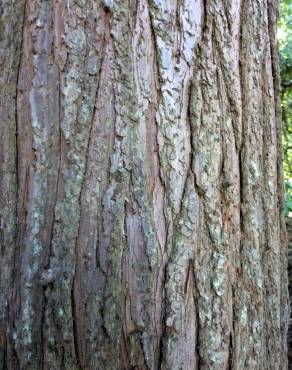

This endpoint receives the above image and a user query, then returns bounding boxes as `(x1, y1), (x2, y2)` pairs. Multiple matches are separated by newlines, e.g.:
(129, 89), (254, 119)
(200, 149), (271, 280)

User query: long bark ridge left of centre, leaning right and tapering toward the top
(74, 12), (114, 368)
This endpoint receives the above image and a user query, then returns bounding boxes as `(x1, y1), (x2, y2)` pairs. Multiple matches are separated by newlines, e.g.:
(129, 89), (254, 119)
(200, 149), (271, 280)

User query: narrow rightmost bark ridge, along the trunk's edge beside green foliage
(262, 2), (283, 368)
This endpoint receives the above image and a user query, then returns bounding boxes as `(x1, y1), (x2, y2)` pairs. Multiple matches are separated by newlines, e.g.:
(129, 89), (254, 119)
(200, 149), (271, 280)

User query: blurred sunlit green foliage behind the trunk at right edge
(278, 0), (292, 217)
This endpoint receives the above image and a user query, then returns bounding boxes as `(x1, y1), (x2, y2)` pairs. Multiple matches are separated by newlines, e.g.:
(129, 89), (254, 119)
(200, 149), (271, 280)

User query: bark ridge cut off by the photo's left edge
(0, 1), (25, 368)
